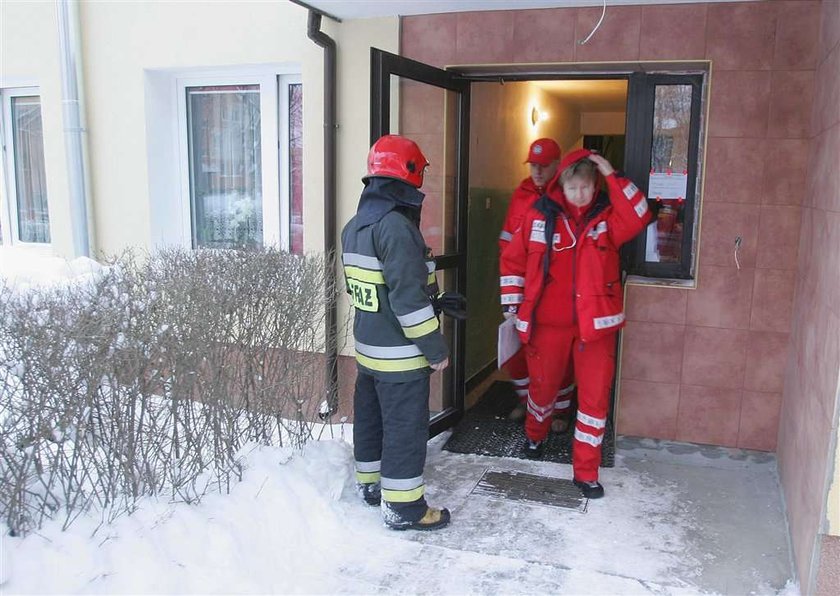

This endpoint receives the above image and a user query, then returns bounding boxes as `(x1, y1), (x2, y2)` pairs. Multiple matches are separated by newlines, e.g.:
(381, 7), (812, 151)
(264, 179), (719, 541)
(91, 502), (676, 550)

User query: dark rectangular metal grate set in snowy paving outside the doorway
(470, 470), (589, 513)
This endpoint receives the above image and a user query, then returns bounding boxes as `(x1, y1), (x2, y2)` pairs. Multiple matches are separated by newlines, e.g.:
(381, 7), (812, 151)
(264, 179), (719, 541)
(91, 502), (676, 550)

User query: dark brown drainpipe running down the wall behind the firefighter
(292, 0), (341, 418)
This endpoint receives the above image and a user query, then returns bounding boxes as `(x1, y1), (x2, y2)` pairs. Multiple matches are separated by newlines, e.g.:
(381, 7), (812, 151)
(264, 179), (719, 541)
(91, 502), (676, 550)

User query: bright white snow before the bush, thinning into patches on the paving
(2, 440), (684, 594)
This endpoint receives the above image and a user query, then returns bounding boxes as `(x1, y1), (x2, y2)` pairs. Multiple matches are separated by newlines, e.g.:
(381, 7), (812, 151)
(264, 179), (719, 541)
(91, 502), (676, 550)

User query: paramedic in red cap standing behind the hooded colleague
(499, 138), (575, 432)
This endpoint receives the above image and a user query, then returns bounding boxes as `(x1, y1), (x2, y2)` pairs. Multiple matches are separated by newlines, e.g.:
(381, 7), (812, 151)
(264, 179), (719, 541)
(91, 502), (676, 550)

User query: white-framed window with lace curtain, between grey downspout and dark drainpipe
(176, 73), (303, 252)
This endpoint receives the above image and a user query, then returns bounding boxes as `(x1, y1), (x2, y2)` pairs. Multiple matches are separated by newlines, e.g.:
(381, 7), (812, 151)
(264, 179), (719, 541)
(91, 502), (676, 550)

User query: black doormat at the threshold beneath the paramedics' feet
(443, 381), (615, 468)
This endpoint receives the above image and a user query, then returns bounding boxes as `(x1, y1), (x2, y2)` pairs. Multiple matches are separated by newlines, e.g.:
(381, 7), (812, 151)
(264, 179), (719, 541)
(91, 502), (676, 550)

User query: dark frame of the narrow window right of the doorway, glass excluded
(622, 71), (708, 283)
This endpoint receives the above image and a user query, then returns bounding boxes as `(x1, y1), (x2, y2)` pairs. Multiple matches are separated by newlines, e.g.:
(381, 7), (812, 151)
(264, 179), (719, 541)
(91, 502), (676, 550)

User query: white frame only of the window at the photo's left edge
(0, 85), (53, 250)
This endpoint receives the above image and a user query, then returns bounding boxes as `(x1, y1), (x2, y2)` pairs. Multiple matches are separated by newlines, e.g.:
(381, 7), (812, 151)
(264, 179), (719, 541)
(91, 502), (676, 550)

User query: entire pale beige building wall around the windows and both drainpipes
(0, 0), (399, 257)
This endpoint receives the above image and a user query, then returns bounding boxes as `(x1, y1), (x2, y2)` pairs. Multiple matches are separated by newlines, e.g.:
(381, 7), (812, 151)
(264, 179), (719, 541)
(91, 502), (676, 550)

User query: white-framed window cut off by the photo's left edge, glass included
(0, 87), (50, 245)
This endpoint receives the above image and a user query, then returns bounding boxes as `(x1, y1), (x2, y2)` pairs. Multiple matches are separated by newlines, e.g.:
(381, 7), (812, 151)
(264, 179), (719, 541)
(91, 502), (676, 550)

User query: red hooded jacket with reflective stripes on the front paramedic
(500, 149), (651, 343)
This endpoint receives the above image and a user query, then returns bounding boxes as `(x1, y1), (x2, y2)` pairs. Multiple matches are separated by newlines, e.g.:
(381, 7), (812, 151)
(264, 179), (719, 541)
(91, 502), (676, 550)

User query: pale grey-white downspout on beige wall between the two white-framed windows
(55, 0), (93, 257)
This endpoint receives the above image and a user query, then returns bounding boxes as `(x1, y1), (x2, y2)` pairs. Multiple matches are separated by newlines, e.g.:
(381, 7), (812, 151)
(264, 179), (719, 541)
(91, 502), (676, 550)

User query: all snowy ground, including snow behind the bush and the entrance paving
(0, 250), (798, 596)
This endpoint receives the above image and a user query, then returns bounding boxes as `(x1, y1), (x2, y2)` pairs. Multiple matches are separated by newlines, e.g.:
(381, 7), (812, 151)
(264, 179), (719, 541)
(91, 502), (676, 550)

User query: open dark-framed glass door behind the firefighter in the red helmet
(370, 48), (470, 436)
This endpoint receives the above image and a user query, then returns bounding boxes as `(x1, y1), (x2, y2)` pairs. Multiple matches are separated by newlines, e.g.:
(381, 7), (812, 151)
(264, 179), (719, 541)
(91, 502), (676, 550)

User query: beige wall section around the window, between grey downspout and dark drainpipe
(81, 2), (323, 253)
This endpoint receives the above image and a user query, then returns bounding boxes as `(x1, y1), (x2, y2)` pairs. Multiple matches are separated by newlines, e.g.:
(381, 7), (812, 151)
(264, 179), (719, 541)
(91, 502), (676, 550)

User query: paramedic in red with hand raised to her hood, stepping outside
(501, 149), (651, 499)
